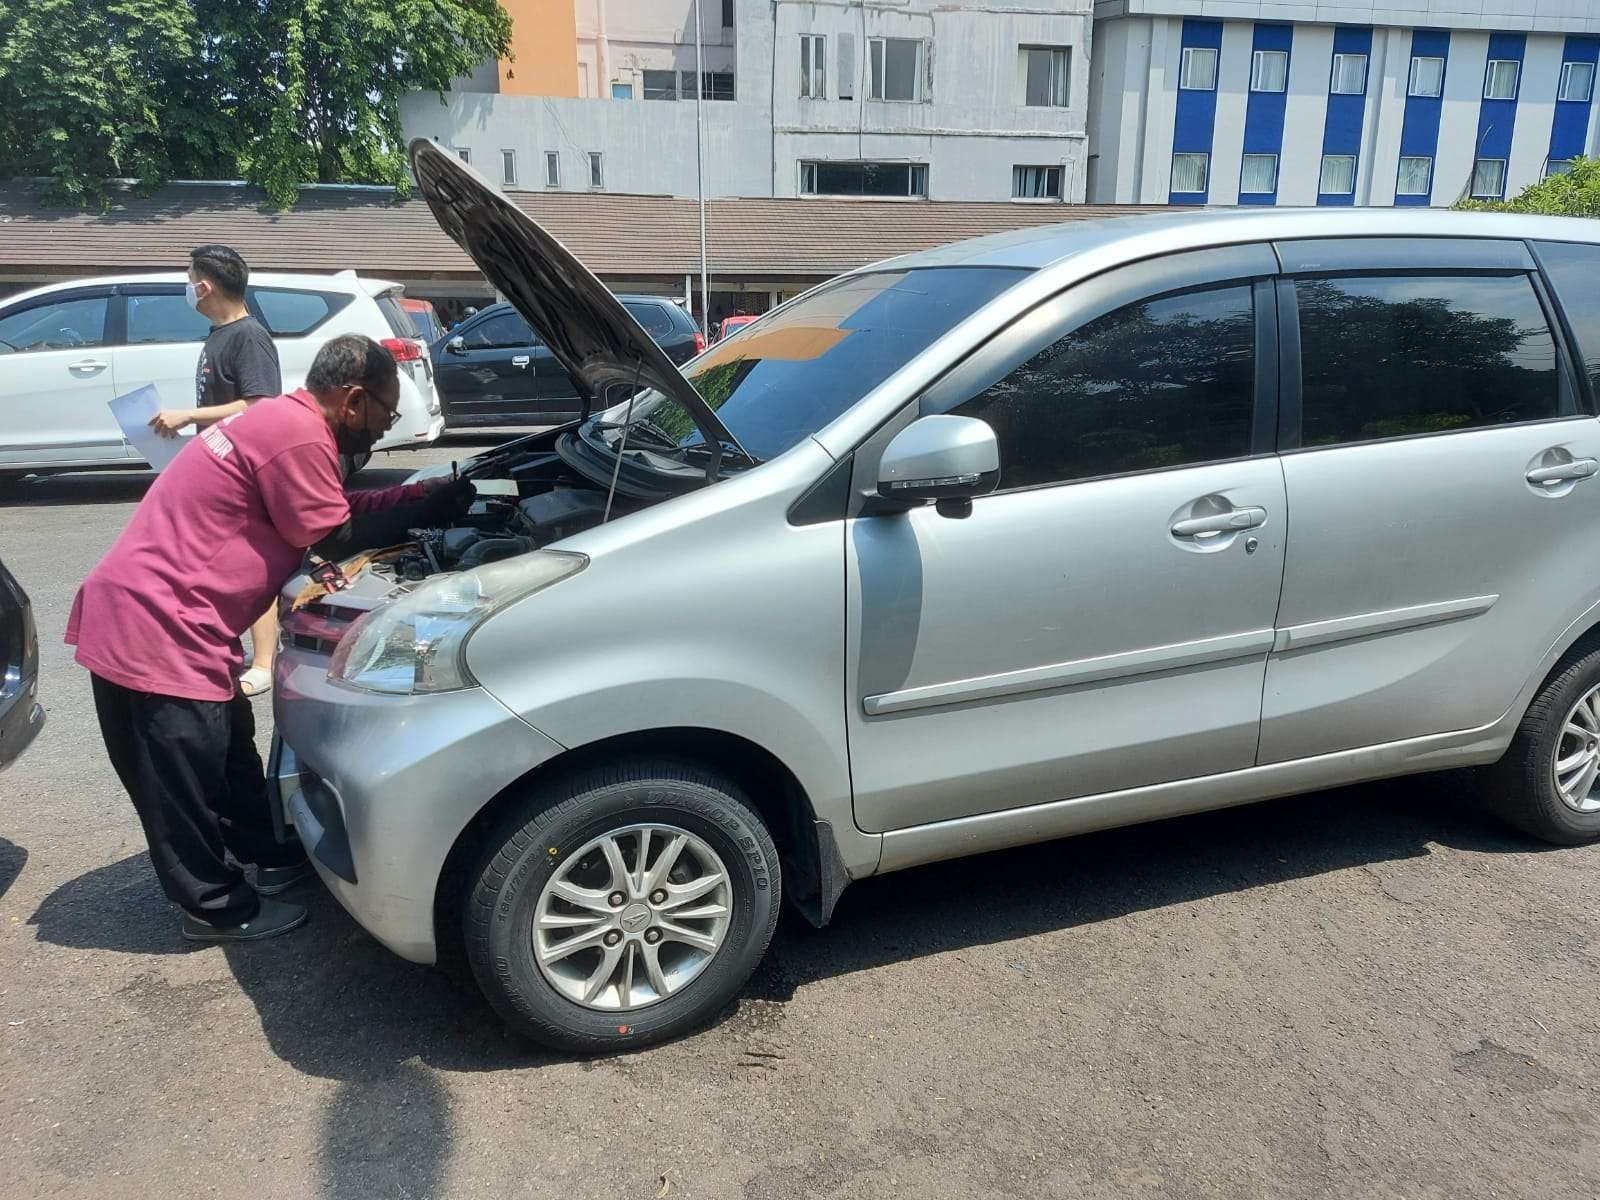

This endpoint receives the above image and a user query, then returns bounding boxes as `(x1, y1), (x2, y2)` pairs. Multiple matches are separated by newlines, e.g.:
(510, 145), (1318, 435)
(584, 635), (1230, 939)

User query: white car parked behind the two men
(0, 270), (445, 472)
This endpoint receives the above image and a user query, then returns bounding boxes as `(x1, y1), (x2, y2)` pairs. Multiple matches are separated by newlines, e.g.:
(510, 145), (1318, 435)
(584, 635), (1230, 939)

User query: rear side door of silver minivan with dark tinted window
(1261, 238), (1600, 763)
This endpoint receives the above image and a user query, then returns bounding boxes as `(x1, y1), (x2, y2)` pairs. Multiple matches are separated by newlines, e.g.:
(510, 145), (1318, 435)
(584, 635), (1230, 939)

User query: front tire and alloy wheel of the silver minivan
(464, 760), (782, 1053)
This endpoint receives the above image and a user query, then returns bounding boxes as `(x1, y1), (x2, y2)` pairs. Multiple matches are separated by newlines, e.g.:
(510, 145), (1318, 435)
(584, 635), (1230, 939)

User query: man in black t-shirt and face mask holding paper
(150, 245), (283, 696)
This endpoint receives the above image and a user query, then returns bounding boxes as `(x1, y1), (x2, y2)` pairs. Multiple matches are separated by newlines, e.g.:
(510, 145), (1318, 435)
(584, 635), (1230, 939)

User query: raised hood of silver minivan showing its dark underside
(411, 138), (739, 446)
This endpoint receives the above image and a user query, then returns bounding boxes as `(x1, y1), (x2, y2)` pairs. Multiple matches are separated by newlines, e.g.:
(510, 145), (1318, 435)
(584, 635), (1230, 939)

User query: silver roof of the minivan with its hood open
(883, 206), (1600, 278)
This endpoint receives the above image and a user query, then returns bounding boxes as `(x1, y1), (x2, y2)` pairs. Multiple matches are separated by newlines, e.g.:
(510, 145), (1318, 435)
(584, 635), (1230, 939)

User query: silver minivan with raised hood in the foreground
(274, 144), (1600, 1051)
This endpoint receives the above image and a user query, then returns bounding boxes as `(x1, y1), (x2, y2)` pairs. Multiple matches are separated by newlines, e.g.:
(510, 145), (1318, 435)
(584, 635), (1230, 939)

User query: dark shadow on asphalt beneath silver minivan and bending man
(28, 774), (1541, 1198)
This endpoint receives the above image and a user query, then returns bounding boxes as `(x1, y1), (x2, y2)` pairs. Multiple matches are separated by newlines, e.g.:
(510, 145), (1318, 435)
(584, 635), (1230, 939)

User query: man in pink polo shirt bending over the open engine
(66, 334), (472, 941)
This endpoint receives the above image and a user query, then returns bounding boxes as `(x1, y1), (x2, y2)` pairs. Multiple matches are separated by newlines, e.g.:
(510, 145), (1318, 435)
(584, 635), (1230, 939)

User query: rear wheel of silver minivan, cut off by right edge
(1483, 650), (1600, 846)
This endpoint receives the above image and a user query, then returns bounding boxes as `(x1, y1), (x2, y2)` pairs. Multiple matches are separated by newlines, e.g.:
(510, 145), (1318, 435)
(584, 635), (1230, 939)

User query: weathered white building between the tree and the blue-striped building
(402, 0), (1093, 203)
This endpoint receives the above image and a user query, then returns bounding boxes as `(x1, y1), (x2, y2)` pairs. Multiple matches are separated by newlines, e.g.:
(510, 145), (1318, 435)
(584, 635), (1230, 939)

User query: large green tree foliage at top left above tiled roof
(0, 0), (510, 206)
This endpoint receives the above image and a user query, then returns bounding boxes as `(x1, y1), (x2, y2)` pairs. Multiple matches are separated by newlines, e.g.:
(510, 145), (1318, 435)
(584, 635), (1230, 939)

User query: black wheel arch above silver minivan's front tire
(434, 726), (850, 960)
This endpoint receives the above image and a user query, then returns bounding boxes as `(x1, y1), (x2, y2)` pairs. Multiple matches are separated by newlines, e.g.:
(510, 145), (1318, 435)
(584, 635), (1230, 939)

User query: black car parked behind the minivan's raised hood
(432, 296), (706, 429)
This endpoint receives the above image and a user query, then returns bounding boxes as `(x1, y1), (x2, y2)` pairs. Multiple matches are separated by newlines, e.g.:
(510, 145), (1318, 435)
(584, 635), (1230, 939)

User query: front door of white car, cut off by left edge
(0, 288), (133, 466)
